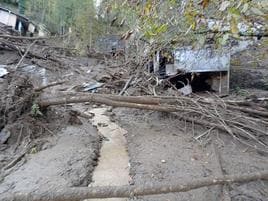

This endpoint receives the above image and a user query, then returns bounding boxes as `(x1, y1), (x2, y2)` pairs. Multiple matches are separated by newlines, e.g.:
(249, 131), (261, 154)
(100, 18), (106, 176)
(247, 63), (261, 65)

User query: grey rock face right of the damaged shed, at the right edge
(230, 39), (268, 90)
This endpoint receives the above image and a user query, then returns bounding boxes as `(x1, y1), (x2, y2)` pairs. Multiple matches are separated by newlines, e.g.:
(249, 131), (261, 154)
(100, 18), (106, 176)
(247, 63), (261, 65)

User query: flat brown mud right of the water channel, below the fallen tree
(114, 109), (268, 201)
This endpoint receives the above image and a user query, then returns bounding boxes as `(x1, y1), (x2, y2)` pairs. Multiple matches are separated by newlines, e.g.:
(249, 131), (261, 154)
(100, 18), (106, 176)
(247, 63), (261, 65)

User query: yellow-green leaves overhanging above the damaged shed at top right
(102, 0), (268, 48)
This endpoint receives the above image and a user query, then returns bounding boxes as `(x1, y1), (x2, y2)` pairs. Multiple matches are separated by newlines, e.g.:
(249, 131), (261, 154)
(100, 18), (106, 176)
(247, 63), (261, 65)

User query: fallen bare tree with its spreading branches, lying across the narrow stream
(39, 93), (268, 152)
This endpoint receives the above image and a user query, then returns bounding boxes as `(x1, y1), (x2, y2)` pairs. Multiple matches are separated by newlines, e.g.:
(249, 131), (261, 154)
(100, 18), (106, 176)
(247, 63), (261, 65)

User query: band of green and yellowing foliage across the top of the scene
(2, 0), (268, 51)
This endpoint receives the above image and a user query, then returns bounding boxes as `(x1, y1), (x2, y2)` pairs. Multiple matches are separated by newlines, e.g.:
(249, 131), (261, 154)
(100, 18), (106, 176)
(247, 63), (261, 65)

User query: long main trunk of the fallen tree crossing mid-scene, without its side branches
(37, 94), (267, 152)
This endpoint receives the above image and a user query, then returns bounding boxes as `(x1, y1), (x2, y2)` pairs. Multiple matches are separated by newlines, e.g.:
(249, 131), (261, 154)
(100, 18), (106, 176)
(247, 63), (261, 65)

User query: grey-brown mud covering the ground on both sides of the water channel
(0, 38), (268, 201)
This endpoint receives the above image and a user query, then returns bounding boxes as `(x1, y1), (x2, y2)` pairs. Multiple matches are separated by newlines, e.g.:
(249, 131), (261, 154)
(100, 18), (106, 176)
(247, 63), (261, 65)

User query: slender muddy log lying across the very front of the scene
(0, 170), (268, 201)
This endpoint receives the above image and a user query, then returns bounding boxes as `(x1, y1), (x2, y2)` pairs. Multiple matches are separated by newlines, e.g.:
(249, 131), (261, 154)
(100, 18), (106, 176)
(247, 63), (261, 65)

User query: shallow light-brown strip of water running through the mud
(88, 108), (129, 201)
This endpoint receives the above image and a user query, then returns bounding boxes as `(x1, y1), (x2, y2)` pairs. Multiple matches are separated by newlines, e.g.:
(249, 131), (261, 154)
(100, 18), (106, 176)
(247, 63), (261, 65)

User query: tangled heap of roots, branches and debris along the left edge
(0, 27), (75, 175)
